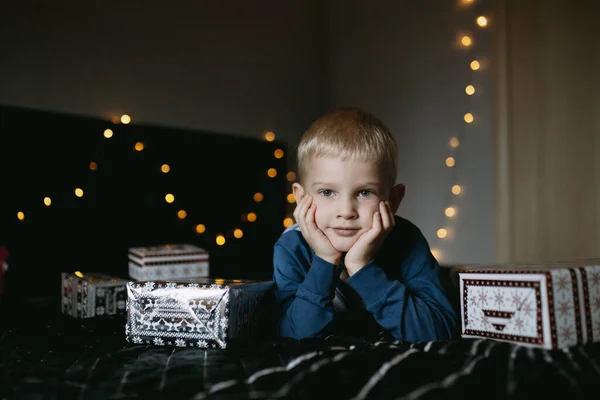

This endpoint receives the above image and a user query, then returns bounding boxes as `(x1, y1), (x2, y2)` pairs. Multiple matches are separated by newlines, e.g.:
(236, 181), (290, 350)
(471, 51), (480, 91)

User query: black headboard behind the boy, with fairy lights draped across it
(0, 107), (287, 296)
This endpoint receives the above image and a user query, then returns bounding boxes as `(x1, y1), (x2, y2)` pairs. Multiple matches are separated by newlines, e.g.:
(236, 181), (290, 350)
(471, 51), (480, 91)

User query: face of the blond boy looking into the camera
(293, 157), (396, 252)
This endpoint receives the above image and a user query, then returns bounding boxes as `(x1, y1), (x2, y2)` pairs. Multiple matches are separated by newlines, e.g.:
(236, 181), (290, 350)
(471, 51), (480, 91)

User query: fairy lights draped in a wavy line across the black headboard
(16, 114), (296, 246)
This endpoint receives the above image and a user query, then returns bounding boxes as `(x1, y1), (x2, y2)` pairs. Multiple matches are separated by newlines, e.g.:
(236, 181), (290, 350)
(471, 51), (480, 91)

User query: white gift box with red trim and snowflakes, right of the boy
(458, 264), (600, 349)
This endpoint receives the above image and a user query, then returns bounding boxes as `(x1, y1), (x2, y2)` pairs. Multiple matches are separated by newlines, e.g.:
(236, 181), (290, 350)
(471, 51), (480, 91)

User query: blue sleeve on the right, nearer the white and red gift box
(348, 234), (457, 342)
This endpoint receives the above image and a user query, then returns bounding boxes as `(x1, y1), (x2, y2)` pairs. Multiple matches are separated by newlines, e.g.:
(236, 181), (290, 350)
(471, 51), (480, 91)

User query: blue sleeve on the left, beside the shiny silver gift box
(273, 245), (341, 340)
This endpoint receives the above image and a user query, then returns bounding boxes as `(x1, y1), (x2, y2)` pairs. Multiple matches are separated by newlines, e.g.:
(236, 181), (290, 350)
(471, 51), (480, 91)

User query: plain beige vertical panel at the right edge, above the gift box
(494, 0), (600, 263)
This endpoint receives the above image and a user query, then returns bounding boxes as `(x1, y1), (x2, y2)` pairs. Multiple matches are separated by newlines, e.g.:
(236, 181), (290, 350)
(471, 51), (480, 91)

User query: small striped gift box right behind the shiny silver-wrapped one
(128, 243), (209, 281)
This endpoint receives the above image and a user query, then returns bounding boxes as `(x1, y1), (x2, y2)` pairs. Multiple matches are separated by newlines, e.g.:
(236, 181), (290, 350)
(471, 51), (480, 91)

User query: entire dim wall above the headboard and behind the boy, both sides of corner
(0, 0), (493, 263)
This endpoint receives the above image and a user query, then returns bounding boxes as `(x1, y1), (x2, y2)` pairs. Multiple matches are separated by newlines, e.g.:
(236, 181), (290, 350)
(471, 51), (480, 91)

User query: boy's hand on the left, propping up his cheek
(294, 195), (342, 265)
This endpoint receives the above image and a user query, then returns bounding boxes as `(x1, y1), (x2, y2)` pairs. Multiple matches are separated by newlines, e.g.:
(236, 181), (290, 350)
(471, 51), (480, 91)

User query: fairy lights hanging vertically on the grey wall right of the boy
(431, 0), (490, 261)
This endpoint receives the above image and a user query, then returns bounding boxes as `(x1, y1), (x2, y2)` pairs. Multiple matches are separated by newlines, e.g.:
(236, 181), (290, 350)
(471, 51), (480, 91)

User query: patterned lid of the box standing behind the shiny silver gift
(128, 243), (208, 265)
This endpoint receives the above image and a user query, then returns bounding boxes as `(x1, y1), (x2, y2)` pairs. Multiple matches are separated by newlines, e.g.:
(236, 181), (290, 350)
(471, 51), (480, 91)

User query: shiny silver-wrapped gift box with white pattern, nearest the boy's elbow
(125, 278), (274, 349)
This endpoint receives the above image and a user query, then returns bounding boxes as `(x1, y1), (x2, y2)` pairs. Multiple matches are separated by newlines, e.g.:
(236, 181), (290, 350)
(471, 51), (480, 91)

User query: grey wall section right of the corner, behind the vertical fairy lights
(329, 0), (495, 263)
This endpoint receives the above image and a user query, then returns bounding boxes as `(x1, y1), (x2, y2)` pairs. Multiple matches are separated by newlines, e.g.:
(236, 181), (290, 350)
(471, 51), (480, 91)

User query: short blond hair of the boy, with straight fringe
(297, 107), (397, 187)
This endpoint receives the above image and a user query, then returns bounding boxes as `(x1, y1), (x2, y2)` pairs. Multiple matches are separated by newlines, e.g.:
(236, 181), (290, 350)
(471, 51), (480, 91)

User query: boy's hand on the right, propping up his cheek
(344, 201), (396, 276)
